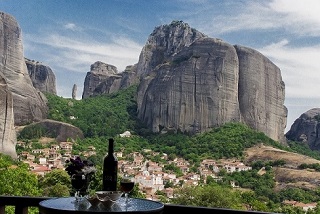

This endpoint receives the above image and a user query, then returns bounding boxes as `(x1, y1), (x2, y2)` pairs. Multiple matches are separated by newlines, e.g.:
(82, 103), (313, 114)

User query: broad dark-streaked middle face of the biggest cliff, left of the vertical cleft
(138, 38), (241, 134)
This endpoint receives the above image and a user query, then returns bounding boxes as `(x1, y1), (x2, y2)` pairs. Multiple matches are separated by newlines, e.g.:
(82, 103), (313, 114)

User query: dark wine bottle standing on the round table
(102, 138), (118, 191)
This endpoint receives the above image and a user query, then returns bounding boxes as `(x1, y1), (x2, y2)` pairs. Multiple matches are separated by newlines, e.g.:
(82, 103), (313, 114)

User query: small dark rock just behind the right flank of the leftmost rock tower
(25, 59), (57, 95)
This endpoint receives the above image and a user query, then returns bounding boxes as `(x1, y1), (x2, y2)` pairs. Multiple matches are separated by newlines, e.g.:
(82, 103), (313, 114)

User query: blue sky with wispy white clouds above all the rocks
(0, 0), (320, 132)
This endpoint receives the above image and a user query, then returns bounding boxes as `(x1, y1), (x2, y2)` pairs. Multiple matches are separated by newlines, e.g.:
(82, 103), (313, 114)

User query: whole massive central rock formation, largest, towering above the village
(137, 22), (287, 142)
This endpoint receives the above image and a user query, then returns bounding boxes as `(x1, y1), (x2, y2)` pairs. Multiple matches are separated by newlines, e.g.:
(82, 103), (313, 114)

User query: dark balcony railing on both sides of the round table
(0, 196), (276, 214)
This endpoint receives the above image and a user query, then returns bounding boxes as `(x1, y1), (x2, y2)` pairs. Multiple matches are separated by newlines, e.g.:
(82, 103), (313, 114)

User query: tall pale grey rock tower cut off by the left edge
(0, 12), (48, 157)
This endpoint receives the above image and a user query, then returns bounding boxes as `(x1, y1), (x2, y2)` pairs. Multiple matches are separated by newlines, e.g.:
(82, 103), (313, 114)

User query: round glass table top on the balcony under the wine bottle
(39, 197), (164, 214)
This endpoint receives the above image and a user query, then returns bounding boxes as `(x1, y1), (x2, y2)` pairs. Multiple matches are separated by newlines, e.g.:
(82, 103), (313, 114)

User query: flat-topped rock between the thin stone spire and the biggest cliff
(82, 61), (138, 99)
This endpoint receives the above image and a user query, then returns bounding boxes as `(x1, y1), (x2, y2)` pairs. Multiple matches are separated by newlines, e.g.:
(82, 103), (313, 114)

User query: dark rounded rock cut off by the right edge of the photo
(285, 108), (320, 150)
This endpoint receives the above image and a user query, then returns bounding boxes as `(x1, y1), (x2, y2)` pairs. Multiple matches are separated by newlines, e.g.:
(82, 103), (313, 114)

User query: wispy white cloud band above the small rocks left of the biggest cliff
(25, 31), (142, 72)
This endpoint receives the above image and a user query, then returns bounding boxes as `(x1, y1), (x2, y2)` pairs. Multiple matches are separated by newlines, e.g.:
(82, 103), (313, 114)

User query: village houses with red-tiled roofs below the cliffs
(17, 142), (251, 200)
